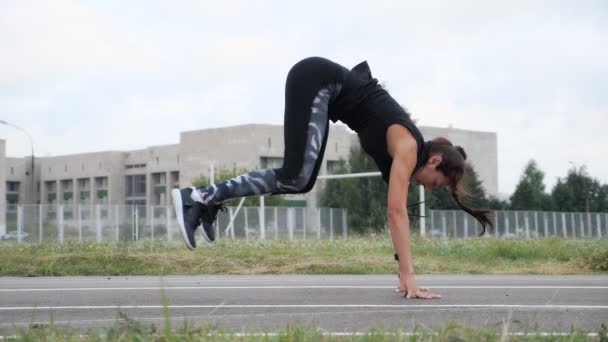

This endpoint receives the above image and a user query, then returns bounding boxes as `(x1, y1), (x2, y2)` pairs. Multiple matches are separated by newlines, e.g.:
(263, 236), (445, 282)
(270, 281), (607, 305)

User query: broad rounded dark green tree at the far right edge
(551, 166), (608, 212)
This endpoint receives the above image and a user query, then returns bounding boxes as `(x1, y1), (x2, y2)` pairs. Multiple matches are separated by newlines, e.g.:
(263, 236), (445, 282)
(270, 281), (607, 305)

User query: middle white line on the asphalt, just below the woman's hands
(0, 304), (608, 311)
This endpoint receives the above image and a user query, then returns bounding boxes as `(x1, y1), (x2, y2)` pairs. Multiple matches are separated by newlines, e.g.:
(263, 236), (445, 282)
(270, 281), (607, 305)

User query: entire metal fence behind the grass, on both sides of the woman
(0, 205), (608, 243)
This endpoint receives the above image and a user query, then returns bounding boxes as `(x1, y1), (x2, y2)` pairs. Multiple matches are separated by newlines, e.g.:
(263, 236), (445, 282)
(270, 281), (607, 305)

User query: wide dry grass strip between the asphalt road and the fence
(0, 235), (608, 276)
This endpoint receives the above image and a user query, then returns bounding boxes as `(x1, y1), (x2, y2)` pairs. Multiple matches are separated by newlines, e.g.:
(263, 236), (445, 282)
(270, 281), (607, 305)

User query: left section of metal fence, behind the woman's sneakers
(0, 205), (348, 243)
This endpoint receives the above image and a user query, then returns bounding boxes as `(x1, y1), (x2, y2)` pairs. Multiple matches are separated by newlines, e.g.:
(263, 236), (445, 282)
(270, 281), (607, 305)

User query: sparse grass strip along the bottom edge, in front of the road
(8, 312), (608, 342)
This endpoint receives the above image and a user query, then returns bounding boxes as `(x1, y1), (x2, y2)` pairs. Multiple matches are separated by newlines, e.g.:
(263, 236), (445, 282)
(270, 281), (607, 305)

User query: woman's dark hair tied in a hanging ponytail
(429, 137), (494, 236)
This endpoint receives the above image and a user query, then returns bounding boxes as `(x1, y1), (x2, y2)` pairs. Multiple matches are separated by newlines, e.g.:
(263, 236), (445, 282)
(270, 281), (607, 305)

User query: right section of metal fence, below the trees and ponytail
(425, 210), (608, 239)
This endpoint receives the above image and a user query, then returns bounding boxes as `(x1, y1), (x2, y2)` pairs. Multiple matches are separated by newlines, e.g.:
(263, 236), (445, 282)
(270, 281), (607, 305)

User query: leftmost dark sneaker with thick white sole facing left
(171, 188), (205, 250)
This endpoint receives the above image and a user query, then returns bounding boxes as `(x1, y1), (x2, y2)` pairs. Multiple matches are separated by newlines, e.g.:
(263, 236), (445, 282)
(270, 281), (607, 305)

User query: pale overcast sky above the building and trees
(0, 0), (608, 193)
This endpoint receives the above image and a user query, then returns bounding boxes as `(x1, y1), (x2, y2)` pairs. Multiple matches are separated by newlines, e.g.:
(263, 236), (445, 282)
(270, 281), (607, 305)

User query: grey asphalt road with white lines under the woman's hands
(0, 275), (608, 335)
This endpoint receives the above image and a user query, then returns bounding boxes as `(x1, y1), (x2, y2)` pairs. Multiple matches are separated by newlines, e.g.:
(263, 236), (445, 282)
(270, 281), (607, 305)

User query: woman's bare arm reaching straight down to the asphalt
(387, 126), (441, 298)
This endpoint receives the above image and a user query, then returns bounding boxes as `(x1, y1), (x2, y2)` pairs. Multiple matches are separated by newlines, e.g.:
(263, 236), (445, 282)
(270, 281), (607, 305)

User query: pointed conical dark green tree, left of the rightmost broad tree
(510, 160), (551, 210)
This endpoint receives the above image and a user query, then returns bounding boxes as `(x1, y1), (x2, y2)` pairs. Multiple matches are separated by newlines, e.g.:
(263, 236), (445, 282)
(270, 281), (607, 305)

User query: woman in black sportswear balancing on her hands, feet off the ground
(172, 57), (490, 298)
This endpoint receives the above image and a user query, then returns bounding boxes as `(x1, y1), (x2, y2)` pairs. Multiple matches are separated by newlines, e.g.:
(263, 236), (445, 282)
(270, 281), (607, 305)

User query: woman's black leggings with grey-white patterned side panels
(193, 57), (348, 203)
